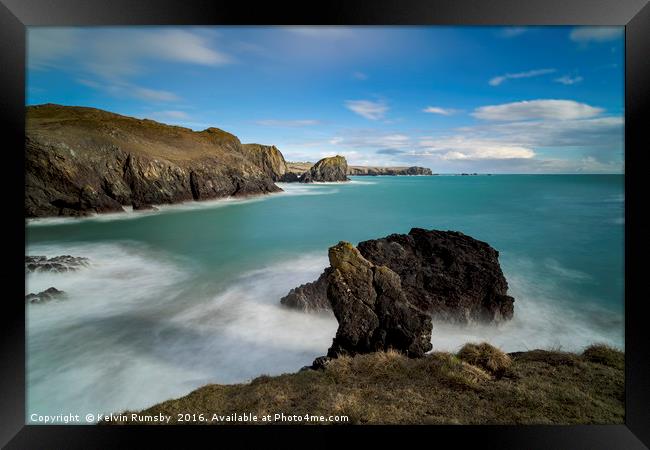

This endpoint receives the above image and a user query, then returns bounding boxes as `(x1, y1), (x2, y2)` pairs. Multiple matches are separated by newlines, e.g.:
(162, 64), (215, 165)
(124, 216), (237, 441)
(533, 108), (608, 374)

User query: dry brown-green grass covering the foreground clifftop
(115, 344), (624, 424)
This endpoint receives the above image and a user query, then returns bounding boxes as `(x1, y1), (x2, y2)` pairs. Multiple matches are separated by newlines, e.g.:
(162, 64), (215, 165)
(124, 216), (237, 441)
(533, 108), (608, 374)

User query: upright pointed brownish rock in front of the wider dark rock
(327, 242), (431, 358)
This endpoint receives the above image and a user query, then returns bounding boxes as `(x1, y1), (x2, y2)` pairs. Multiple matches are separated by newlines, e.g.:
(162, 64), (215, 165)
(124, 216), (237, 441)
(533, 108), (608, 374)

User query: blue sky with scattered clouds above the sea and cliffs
(27, 26), (624, 173)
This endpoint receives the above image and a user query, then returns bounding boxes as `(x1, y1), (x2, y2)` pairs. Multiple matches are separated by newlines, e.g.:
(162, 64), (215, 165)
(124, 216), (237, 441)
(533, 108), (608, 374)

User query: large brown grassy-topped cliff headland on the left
(25, 104), (284, 217)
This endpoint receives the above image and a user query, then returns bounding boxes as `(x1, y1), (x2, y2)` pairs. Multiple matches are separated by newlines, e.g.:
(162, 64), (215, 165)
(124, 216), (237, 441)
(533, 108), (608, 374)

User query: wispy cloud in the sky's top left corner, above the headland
(28, 28), (233, 102)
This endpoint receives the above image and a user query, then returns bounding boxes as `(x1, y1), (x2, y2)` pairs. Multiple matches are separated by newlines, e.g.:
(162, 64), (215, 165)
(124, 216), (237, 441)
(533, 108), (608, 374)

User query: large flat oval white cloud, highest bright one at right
(472, 99), (603, 121)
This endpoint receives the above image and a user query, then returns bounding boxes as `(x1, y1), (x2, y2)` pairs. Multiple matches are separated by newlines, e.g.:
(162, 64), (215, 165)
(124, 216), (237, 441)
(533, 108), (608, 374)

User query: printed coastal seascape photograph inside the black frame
(24, 26), (625, 426)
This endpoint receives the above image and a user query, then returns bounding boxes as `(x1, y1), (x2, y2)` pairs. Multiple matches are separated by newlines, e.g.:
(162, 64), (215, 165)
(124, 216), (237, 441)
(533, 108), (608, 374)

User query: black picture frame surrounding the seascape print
(0, 0), (650, 450)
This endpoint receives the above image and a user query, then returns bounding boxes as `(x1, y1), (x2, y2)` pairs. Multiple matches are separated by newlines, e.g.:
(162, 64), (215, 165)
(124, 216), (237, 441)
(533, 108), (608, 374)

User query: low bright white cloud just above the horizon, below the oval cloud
(411, 136), (535, 160)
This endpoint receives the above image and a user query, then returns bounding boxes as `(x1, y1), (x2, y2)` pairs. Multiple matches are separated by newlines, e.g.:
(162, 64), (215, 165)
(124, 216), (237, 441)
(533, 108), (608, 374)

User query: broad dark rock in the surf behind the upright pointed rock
(280, 228), (514, 323)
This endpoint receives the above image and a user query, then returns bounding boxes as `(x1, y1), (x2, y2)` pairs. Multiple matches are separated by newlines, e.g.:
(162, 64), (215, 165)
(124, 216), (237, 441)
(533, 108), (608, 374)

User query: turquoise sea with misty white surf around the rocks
(26, 175), (624, 420)
